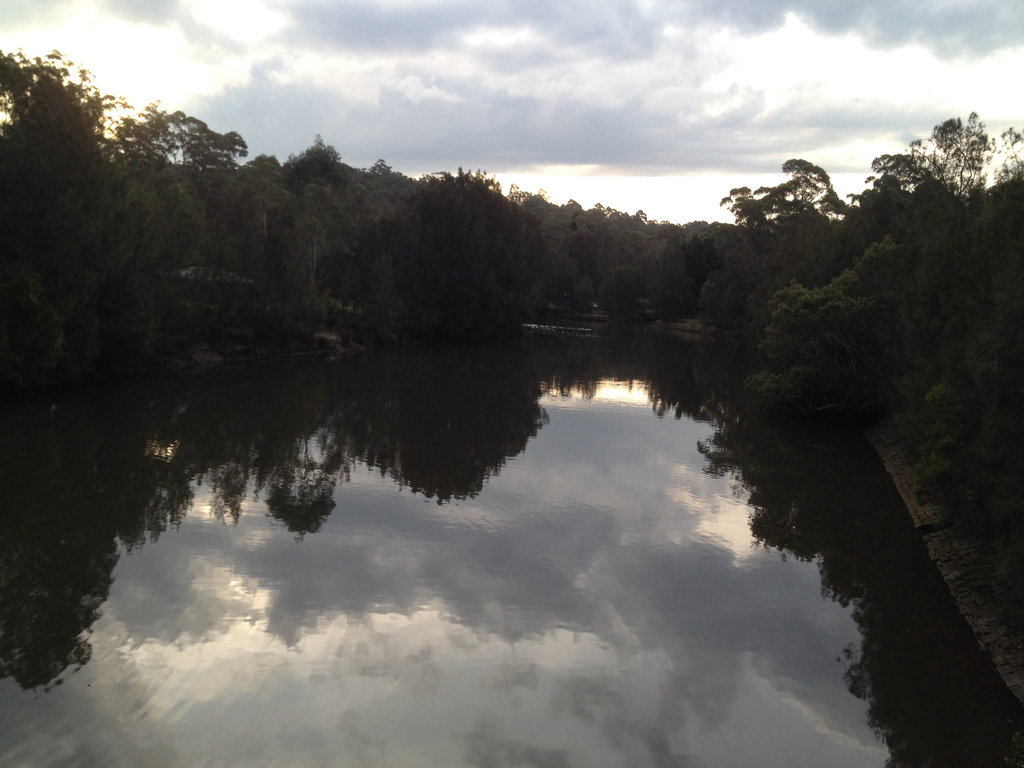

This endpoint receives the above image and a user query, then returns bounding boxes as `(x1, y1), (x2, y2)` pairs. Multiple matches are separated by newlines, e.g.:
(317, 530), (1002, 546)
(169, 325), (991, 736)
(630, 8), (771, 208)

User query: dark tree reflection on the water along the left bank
(0, 344), (545, 688)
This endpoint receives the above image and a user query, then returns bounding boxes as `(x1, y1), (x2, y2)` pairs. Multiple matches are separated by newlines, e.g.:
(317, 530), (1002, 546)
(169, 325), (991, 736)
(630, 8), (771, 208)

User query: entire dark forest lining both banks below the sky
(0, 53), (1024, 609)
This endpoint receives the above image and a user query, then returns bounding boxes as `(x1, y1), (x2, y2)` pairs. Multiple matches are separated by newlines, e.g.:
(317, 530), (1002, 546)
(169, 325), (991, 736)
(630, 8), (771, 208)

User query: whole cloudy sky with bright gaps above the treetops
(0, 0), (1024, 223)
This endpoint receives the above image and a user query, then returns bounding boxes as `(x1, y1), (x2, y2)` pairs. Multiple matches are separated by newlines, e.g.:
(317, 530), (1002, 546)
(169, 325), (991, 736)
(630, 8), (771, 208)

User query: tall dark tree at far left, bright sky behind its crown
(0, 52), (119, 381)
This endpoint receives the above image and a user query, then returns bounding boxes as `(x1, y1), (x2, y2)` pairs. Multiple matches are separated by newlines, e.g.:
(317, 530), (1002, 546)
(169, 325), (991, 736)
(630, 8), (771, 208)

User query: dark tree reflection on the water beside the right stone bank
(701, 414), (1022, 768)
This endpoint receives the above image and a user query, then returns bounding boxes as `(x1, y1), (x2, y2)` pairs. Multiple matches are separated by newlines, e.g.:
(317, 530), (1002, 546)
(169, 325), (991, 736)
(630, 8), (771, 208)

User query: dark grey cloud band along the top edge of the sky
(276, 0), (1024, 61)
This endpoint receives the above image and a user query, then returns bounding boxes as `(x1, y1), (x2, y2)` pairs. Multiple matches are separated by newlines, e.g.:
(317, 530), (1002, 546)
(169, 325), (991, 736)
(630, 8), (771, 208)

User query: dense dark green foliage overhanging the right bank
(727, 115), (1024, 609)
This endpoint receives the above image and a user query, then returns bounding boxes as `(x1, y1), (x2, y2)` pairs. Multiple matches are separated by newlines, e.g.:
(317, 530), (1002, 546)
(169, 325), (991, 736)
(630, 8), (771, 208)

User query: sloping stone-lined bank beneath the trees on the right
(865, 425), (1024, 703)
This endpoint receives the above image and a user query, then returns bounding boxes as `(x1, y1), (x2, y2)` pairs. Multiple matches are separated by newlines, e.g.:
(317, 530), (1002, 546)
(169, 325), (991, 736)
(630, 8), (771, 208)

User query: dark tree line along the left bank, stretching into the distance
(0, 52), (695, 387)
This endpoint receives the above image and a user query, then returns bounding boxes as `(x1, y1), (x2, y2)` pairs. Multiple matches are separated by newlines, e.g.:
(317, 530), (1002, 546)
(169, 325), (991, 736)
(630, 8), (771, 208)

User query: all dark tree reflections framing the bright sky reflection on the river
(0, 328), (1021, 766)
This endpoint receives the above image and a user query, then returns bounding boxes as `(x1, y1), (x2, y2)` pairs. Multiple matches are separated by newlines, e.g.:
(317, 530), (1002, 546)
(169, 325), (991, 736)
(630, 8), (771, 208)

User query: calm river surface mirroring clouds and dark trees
(0, 328), (1024, 768)
